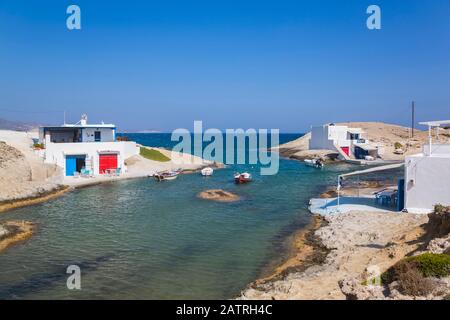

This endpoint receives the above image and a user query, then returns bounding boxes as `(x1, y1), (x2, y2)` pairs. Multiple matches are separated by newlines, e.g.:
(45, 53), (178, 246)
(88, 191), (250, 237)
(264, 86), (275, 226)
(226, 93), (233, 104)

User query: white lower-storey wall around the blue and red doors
(44, 141), (139, 175)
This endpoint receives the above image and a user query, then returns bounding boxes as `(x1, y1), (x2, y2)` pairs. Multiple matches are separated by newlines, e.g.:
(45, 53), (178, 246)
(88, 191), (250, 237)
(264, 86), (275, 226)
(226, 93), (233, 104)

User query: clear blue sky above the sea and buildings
(0, 0), (450, 132)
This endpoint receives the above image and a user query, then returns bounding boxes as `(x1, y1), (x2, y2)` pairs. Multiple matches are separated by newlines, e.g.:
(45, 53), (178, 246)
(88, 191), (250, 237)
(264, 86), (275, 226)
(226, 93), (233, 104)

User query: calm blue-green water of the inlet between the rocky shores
(0, 134), (356, 299)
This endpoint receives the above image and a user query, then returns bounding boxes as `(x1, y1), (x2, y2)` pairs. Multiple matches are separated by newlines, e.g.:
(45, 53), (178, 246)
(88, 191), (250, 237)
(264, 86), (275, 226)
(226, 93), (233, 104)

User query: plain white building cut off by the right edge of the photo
(405, 120), (450, 213)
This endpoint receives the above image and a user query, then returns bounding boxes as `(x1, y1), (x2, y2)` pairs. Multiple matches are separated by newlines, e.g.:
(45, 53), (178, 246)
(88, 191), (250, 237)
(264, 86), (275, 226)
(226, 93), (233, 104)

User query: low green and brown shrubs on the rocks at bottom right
(381, 253), (450, 296)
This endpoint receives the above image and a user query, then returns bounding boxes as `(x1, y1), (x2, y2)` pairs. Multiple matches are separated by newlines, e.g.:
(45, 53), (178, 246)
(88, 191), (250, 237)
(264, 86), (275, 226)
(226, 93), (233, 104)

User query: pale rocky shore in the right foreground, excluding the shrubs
(237, 192), (450, 300)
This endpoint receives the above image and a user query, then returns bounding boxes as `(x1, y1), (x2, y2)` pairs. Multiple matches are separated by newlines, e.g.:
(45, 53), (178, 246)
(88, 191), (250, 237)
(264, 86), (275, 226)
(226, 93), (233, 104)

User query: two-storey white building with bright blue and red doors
(39, 115), (139, 176)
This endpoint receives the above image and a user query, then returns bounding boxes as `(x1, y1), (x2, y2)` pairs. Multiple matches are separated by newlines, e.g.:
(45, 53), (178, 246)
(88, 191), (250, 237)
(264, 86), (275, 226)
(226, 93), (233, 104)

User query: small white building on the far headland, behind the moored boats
(309, 123), (378, 159)
